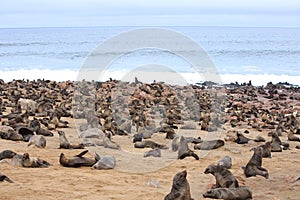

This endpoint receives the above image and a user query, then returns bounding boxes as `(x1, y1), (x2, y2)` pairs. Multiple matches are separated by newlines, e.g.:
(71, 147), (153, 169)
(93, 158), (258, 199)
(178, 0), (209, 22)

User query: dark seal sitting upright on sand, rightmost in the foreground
(242, 147), (269, 179)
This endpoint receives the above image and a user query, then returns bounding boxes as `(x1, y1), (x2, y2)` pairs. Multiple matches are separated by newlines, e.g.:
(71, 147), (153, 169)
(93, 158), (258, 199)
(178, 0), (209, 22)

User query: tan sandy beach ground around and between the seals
(0, 79), (300, 200)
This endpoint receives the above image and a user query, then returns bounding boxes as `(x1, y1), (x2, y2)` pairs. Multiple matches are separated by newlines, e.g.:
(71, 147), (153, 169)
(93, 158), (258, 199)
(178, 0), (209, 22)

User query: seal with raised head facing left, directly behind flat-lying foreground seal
(204, 165), (239, 188)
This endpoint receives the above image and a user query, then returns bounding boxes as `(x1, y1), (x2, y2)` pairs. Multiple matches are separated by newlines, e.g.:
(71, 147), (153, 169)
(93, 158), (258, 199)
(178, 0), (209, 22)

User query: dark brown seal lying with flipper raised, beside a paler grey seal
(59, 150), (100, 167)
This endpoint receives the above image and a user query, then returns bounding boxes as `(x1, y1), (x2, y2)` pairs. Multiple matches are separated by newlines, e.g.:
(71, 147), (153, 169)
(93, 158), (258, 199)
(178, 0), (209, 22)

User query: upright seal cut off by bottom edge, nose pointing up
(164, 170), (193, 200)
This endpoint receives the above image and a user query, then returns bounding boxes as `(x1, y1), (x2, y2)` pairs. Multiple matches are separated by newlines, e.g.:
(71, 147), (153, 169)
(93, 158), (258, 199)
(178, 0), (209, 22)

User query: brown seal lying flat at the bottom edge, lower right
(203, 186), (252, 200)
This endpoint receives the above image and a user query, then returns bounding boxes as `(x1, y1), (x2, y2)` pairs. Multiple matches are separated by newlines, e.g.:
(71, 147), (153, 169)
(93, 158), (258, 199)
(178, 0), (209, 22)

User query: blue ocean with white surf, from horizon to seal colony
(0, 26), (300, 85)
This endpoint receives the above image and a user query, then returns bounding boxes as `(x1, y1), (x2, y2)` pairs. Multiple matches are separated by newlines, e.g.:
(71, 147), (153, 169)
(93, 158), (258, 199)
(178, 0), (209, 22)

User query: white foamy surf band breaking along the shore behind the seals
(0, 69), (300, 86)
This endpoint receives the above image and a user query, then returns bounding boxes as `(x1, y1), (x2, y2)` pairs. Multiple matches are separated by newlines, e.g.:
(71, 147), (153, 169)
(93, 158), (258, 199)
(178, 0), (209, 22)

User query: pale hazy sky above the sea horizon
(0, 0), (300, 27)
